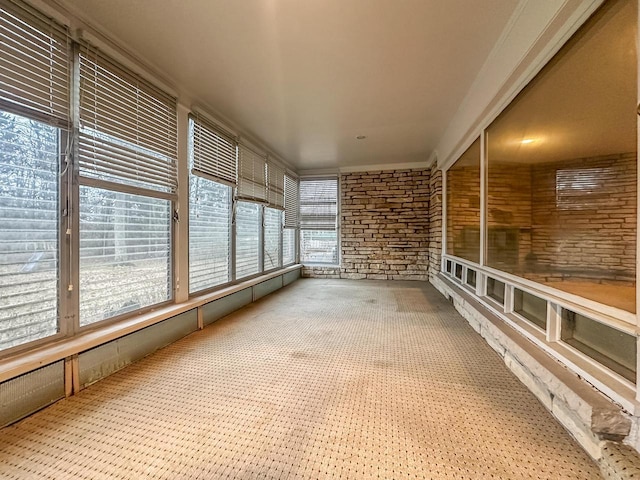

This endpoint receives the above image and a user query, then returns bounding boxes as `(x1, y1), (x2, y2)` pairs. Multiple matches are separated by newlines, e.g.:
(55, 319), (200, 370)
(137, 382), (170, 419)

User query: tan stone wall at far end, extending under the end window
(303, 169), (430, 280)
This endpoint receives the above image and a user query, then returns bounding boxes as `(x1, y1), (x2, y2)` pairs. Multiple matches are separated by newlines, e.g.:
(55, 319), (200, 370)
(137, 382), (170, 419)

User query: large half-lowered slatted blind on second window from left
(79, 44), (177, 194)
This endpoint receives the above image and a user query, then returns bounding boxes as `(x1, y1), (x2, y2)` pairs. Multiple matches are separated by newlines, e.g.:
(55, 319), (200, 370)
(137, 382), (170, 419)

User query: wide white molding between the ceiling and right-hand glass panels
(436, 0), (603, 170)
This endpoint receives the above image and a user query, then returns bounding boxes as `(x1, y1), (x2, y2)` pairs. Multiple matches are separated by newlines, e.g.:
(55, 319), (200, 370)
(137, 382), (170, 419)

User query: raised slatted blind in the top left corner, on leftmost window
(0, 0), (71, 128)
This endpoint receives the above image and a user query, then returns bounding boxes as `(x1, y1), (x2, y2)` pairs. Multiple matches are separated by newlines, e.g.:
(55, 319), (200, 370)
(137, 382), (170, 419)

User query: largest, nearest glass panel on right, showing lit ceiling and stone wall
(486, 0), (638, 312)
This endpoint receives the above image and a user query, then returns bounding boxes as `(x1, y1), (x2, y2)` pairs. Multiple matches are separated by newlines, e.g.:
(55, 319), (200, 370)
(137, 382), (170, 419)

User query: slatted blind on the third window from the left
(191, 114), (237, 187)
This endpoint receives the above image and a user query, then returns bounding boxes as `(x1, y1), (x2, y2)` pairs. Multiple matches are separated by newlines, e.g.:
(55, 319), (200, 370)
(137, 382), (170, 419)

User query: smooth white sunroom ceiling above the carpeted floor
(58, 0), (518, 169)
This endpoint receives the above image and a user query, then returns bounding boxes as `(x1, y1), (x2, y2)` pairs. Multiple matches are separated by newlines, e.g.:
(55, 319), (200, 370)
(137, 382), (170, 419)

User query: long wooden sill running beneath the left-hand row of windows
(0, 264), (302, 382)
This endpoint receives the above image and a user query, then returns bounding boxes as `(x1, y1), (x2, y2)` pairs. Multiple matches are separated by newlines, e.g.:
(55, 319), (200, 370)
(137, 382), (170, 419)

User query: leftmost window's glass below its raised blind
(0, 112), (59, 350)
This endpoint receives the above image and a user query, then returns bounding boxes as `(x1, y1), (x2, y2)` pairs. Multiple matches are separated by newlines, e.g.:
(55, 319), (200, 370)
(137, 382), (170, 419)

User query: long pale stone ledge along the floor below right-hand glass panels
(431, 275), (632, 462)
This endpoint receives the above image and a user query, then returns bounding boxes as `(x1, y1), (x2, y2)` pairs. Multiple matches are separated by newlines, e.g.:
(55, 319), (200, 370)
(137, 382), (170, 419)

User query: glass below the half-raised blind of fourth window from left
(235, 202), (262, 279)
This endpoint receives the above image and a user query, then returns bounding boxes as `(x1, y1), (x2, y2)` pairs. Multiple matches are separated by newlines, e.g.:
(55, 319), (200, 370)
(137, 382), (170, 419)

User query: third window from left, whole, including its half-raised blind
(189, 115), (236, 293)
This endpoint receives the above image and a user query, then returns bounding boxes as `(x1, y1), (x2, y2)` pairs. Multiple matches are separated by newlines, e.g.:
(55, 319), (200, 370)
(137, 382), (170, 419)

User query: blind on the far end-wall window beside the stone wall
(300, 178), (338, 231)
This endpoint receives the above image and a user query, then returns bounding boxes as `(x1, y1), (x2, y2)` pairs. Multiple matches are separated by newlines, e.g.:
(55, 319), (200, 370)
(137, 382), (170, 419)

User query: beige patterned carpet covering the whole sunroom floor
(0, 279), (599, 480)
